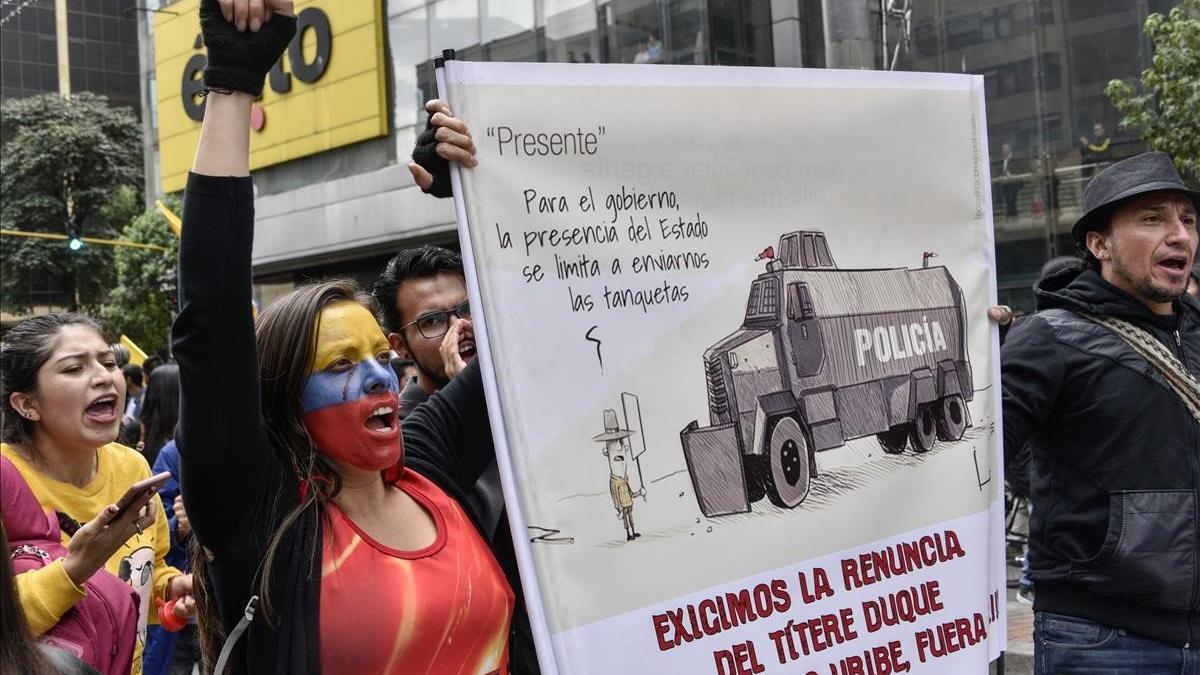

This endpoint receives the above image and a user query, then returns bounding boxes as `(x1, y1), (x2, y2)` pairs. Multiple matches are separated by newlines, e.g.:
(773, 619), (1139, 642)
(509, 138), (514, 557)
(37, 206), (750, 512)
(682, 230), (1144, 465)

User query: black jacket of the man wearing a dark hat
(1001, 265), (1200, 646)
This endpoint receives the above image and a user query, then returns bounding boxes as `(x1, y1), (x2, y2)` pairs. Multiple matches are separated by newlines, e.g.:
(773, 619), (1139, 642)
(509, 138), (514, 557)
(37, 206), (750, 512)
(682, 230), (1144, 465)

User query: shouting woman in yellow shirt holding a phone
(0, 315), (194, 674)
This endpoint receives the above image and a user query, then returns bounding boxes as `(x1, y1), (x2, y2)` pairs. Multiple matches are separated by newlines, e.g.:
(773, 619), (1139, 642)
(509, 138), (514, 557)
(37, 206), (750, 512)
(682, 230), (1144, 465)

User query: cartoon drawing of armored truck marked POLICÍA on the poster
(680, 231), (974, 516)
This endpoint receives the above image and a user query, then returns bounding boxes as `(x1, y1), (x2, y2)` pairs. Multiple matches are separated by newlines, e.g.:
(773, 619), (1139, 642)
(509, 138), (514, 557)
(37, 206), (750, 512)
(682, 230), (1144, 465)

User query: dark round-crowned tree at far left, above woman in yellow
(0, 94), (142, 312)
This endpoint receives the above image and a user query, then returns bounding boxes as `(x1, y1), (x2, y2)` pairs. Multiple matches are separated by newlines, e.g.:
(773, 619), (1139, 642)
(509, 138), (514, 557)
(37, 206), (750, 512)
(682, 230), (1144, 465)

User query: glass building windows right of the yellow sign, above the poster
(389, 0), (768, 162)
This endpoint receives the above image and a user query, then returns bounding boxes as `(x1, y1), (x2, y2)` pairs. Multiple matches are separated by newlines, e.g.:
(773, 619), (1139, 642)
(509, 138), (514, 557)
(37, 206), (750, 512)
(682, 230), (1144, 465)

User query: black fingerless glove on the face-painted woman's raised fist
(200, 0), (296, 98)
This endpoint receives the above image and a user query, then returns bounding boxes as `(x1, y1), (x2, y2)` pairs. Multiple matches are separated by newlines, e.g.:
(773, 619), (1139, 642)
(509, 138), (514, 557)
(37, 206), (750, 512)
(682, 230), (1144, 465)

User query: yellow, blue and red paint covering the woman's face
(300, 301), (403, 471)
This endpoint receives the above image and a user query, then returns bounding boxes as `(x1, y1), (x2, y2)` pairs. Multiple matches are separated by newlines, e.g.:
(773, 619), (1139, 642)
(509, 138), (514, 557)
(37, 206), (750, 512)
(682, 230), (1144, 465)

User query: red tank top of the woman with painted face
(320, 471), (514, 675)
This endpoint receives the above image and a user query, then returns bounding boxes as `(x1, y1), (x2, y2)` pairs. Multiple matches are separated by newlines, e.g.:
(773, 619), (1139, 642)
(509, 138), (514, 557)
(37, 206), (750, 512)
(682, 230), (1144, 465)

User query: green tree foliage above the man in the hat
(1105, 0), (1200, 180)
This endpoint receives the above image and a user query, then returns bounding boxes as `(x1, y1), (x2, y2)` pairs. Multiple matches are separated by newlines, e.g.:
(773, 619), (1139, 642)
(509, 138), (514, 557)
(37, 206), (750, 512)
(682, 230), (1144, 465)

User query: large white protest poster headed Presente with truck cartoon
(443, 61), (1004, 675)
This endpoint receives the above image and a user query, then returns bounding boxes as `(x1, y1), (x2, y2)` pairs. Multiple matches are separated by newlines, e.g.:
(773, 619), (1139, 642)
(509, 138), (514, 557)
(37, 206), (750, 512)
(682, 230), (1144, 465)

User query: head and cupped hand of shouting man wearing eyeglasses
(371, 245), (475, 418)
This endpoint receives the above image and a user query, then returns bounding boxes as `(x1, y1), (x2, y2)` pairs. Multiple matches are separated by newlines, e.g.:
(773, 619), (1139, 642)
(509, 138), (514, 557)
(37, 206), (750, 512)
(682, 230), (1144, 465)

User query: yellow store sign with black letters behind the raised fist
(155, 0), (388, 192)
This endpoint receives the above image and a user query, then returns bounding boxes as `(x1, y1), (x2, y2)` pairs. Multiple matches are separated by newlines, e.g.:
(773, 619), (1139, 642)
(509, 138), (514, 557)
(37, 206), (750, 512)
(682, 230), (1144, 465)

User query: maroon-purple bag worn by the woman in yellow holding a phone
(0, 456), (139, 675)
